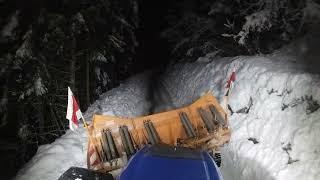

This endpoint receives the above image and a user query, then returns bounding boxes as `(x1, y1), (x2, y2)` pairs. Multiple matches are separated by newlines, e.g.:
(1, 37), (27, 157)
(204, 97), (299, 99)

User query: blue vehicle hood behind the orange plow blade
(117, 145), (222, 180)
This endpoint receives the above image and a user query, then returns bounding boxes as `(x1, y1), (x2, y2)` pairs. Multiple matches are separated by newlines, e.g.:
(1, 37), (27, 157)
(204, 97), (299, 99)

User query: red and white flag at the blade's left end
(66, 87), (83, 131)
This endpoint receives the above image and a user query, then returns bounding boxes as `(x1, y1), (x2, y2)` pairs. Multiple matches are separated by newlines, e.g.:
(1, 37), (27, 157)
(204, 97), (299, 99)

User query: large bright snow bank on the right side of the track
(163, 52), (320, 180)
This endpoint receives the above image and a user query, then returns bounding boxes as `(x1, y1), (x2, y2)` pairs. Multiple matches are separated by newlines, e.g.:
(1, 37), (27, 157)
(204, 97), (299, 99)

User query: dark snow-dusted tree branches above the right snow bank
(163, 0), (319, 60)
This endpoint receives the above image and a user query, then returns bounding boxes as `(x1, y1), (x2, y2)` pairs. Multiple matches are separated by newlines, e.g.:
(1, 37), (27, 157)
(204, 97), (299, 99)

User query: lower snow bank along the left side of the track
(15, 74), (150, 180)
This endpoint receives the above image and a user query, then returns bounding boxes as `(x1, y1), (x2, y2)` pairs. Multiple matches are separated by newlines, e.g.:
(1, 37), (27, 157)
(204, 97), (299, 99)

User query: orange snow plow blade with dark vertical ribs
(87, 93), (231, 172)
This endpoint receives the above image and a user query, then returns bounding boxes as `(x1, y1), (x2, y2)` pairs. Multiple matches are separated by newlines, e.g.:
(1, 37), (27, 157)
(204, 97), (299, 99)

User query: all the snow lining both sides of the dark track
(16, 34), (320, 180)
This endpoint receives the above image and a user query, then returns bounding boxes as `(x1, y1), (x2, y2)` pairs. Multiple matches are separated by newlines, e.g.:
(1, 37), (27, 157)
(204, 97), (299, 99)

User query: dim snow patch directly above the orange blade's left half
(84, 72), (151, 119)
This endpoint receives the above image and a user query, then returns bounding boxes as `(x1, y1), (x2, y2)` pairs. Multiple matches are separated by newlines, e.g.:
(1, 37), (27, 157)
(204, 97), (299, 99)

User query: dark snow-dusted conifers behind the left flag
(0, 0), (138, 178)
